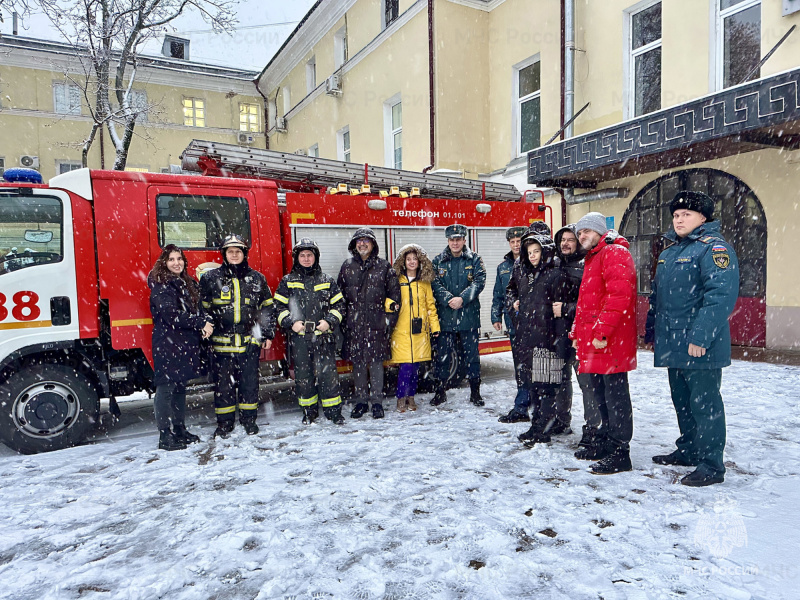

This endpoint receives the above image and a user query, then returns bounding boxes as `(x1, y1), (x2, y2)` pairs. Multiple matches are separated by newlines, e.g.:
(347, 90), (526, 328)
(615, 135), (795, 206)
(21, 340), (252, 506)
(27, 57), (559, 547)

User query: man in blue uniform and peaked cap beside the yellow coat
(431, 224), (486, 406)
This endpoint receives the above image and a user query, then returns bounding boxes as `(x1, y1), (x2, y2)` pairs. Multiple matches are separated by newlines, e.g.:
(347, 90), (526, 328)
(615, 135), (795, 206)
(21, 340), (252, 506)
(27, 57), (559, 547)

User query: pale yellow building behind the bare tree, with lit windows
(0, 36), (265, 179)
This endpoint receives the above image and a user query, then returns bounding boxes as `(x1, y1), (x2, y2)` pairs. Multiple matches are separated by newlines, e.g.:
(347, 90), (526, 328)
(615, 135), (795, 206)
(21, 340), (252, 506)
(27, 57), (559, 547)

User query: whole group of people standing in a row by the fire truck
(148, 192), (738, 485)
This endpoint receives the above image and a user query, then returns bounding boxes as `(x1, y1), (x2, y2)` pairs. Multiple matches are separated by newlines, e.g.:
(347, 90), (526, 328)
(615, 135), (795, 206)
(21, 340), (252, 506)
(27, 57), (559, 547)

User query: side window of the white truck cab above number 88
(0, 192), (64, 275)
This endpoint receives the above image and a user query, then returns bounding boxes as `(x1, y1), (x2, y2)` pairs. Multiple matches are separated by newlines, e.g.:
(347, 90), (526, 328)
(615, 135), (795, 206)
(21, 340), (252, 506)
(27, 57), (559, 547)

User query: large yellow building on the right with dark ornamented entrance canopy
(258, 0), (800, 348)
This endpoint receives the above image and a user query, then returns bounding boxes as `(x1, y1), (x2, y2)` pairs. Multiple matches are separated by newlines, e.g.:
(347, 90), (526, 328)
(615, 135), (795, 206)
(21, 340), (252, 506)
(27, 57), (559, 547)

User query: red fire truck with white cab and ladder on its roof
(0, 141), (552, 453)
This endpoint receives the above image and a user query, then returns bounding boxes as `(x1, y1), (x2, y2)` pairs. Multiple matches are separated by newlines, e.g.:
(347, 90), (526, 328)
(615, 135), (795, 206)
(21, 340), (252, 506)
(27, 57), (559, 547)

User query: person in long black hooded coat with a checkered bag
(506, 232), (565, 445)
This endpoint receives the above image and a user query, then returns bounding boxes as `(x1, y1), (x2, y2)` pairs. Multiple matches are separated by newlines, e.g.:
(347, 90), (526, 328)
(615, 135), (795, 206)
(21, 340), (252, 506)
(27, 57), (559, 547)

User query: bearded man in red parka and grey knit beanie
(569, 212), (637, 475)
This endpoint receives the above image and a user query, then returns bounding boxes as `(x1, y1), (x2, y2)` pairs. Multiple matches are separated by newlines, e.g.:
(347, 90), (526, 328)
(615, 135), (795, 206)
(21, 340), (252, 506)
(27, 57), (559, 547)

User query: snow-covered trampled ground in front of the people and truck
(0, 352), (800, 600)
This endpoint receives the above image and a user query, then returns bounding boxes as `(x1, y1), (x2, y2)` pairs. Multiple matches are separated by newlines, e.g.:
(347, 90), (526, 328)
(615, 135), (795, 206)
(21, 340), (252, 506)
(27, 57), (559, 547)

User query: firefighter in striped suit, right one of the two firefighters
(275, 238), (345, 425)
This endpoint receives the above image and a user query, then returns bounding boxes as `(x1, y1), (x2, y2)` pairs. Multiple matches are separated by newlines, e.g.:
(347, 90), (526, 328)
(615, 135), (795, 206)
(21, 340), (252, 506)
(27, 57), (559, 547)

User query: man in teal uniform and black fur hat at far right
(645, 191), (739, 487)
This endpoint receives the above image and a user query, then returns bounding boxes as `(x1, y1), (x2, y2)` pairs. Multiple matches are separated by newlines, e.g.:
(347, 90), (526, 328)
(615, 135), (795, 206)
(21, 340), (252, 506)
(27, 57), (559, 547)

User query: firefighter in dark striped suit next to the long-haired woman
(200, 235), (275, 438)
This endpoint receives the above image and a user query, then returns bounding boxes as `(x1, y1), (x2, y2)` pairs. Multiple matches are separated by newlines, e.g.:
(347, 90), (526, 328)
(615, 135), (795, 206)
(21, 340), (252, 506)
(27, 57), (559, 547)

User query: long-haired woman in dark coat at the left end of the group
(147, 244), (214, 450)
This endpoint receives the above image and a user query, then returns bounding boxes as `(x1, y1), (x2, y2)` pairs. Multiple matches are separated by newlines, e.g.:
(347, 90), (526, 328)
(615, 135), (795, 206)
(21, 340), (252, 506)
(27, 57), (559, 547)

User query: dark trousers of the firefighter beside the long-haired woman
(214, 345), (260, 423)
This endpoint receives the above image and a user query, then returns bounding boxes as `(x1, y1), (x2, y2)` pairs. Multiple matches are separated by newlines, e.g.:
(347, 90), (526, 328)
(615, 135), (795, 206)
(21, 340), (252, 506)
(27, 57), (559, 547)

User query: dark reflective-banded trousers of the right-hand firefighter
(290, 334), (342, 408)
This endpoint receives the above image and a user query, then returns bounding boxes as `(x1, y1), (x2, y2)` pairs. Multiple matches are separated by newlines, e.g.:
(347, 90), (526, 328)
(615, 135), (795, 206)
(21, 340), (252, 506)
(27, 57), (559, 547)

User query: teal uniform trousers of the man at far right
(667, 369), (725, 474)
